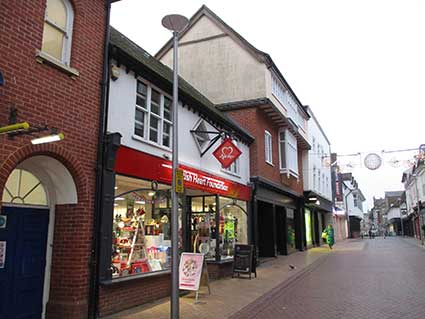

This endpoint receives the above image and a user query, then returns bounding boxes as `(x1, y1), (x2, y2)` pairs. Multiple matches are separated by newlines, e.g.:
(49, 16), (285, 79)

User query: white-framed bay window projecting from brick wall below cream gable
(279, 130), (299, 177)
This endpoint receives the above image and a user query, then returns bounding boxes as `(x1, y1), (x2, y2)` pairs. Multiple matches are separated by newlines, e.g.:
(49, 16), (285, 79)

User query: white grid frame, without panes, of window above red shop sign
(133, 77), (174, 150)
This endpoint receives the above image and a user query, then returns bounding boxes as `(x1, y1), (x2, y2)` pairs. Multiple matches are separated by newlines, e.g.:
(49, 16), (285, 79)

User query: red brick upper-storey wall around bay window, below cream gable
(227, 107), (303, 195)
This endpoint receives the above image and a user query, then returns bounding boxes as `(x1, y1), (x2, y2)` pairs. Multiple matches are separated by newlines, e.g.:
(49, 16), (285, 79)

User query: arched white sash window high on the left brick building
(41, 0), (74, 65)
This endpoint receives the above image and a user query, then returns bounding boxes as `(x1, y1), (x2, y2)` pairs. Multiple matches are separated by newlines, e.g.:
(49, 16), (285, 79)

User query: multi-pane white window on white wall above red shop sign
(134, 80), (173, 148)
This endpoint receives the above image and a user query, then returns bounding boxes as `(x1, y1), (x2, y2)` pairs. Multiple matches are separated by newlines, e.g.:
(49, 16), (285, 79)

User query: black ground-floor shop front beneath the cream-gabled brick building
(251, 177), (305, 258)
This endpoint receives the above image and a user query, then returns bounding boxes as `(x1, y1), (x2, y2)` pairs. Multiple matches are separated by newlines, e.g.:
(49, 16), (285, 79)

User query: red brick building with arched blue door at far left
(0, 0), (109, 318)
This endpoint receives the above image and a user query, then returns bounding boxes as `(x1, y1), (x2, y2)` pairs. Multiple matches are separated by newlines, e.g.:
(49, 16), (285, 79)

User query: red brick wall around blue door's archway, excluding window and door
(0, 0), (105, 318)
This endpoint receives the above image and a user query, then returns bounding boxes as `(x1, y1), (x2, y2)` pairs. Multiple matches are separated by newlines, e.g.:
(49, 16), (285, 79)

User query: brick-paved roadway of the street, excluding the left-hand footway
(231, 238), (425, 319)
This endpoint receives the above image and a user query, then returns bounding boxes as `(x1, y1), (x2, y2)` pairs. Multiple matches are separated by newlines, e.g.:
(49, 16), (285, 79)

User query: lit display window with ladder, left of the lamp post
(111, 175), (182, 278)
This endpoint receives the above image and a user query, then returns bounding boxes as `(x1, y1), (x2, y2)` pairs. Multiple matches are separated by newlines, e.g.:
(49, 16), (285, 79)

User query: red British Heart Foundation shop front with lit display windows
(97, 146), (251, 314)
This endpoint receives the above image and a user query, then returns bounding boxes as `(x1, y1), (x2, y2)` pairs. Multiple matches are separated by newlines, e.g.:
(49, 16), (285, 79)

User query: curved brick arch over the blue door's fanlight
(0, 144), (90, 203)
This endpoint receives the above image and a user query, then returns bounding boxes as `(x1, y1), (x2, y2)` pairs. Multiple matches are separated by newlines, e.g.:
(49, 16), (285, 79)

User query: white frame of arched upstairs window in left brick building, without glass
(41, 0), (74, 67)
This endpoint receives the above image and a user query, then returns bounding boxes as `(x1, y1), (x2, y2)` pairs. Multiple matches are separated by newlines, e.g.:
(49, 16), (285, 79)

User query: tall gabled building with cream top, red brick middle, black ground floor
(156, 6), (311, 257)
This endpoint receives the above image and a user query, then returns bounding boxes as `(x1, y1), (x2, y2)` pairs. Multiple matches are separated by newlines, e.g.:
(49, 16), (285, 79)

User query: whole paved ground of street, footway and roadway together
(102, 237), (425, 319)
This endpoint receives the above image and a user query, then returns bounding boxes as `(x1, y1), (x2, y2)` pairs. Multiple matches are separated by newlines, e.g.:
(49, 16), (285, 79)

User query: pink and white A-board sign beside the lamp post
(179, 253), (204, 291)
